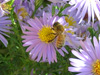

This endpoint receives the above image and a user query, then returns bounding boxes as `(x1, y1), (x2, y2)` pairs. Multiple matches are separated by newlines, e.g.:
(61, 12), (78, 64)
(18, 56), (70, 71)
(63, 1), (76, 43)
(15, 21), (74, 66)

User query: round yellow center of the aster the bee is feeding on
(38, 26), (56, 43)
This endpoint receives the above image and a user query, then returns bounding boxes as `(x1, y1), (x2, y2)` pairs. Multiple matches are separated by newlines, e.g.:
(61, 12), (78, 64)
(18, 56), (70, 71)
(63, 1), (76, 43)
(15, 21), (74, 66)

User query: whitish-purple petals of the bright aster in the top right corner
(69, 0), (100, 23)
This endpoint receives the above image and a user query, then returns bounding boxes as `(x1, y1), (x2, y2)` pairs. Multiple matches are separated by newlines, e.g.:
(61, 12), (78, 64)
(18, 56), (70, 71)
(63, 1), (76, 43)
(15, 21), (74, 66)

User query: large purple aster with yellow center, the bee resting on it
(22, 12), (68, 63)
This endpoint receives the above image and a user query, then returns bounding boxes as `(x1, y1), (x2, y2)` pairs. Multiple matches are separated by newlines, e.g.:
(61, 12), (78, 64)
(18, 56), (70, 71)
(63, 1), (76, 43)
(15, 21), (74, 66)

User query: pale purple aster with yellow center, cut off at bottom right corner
(68, 35), (100, 75)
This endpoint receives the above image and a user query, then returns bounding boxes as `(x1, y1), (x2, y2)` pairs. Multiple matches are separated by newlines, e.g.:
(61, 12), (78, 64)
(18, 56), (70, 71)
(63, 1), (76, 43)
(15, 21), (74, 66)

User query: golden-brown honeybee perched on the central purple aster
(52, 22), (66, 49)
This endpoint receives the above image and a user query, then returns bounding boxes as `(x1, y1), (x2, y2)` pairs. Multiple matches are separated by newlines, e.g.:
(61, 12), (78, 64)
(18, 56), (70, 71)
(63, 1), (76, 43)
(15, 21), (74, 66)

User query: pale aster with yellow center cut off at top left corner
(0, 0), (11, 17)
